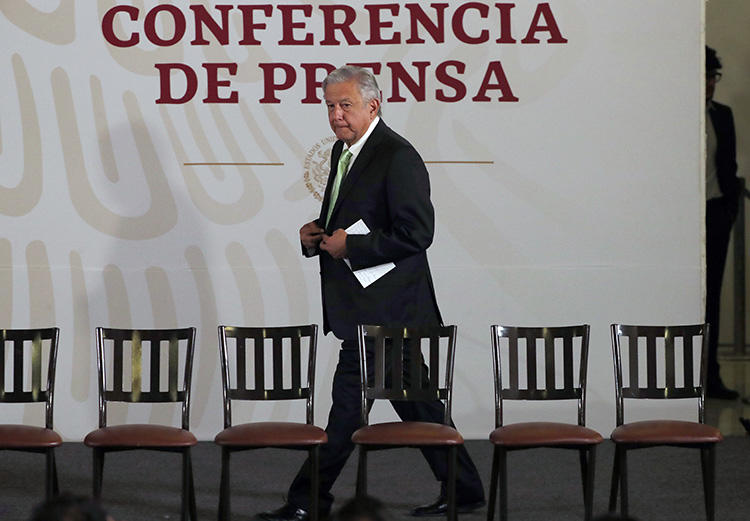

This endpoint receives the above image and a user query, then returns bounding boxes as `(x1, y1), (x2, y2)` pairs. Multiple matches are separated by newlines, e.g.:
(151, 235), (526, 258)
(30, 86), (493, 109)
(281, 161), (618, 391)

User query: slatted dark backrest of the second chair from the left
(96, 327), (195, 429)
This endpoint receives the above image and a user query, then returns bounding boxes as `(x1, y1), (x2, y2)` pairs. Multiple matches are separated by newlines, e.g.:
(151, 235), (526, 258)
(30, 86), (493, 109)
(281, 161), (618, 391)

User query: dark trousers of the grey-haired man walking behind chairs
(287, 340), (484, 513)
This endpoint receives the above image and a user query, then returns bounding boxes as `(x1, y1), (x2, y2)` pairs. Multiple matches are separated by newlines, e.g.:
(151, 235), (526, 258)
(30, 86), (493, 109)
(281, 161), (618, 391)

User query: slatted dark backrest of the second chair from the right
(490, 324), (590, 427)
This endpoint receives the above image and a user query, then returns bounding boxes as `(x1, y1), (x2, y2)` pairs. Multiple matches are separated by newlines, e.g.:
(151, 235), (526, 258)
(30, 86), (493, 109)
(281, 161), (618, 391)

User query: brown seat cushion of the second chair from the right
(490, 422), (603, 447)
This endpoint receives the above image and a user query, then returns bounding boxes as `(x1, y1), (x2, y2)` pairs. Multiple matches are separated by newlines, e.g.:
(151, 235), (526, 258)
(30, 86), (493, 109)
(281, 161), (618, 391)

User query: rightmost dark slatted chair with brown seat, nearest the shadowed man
(609, 324), (722, 521)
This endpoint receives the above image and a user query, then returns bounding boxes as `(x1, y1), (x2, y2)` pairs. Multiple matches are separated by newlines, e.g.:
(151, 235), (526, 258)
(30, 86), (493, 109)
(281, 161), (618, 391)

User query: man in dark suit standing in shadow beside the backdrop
(706, 47), (741, 400)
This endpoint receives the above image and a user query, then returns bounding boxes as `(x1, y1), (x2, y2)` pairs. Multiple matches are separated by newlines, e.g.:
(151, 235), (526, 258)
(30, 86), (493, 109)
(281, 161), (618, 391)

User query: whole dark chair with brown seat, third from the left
(214, 324), (328, 521)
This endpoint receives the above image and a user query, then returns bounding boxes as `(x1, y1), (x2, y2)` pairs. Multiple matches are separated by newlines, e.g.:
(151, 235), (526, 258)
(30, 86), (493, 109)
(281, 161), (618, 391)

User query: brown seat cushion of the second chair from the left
(83, 424), (198, 448)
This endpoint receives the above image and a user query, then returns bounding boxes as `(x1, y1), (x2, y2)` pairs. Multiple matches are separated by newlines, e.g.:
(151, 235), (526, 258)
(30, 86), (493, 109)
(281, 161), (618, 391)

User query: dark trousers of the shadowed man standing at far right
(706, 197), (737, 386)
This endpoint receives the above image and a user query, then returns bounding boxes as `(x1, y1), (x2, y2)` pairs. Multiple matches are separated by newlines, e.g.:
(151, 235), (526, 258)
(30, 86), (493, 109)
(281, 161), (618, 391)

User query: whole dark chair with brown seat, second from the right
(487, 325), (602, 521)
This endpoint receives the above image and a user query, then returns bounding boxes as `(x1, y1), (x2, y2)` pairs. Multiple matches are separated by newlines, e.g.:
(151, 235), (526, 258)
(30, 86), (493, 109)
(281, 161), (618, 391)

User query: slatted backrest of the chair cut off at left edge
(0, 327), (60, 429)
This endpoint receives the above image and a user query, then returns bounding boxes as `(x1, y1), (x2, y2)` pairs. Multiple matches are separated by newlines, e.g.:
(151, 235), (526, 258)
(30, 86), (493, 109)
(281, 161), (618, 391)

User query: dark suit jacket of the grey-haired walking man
(303, 119), (442, 340)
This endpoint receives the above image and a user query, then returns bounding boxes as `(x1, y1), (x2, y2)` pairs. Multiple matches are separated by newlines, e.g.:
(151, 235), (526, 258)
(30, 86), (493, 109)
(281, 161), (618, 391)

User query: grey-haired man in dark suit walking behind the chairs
(259, 66), (484, 521)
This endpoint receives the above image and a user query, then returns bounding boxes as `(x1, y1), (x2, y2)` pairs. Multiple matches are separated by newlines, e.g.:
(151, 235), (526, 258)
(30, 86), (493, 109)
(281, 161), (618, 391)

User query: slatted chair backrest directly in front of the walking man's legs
(357, 325), (457, 425)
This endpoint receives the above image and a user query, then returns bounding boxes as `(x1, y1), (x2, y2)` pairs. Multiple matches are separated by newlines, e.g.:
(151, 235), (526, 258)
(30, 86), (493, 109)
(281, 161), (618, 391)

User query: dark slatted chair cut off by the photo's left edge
(0, 327), (62, 499)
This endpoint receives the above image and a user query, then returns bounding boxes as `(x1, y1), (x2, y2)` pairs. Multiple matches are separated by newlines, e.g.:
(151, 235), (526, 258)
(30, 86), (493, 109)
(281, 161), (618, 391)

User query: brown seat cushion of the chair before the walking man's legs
(352, 422), (464, 445)
